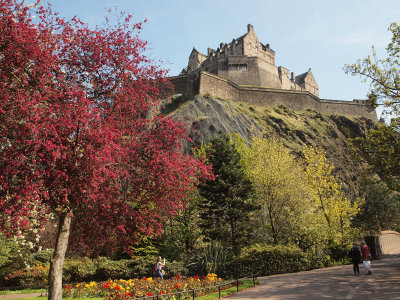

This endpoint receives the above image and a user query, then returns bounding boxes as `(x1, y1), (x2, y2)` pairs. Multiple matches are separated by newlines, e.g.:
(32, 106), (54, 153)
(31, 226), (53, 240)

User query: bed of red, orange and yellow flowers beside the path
(64, 274), (223, 299)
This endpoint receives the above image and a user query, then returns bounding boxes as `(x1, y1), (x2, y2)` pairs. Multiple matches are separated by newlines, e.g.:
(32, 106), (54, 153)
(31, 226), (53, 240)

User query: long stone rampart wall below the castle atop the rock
(171, 71), (377, 121)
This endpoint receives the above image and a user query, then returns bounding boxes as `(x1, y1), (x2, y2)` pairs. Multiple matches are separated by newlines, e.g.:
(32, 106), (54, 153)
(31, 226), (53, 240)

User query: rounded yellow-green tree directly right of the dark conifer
(241, 138), (316, 249)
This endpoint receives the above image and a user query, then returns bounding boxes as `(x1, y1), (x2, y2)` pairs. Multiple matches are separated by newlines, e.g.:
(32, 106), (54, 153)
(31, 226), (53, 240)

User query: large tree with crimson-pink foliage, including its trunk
(0, 0), (210, 299)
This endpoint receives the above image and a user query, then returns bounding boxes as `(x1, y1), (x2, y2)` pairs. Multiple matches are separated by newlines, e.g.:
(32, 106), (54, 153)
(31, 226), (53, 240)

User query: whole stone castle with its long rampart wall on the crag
(170, 24), (377, 121)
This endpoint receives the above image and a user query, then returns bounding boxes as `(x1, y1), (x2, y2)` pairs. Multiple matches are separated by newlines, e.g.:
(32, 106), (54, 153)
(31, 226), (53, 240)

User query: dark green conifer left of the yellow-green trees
(199, 134), (256, 252)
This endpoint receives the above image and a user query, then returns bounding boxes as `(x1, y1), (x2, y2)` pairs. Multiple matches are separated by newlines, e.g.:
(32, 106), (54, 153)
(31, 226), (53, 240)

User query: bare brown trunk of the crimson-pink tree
(48, 214), (71, 300)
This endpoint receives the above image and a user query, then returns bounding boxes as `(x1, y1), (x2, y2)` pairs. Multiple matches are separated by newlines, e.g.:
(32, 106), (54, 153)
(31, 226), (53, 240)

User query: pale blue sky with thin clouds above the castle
(50, 0), (400, 116)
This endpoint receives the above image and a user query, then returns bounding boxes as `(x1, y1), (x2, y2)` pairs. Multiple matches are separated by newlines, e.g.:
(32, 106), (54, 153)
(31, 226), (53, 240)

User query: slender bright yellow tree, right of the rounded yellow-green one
(303, 146), (362, 245)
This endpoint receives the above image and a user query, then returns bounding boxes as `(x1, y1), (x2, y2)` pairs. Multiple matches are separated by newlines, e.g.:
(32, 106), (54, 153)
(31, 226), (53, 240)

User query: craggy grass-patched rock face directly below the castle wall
(167, 95), (376, 197)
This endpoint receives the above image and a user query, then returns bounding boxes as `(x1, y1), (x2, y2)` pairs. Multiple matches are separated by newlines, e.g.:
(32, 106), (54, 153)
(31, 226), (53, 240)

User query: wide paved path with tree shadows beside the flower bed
(227, 249), (400, 300)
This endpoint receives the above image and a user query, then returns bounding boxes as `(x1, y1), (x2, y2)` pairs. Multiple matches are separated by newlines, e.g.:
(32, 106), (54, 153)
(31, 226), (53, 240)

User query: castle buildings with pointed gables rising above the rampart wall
(180, 24), (318, 97)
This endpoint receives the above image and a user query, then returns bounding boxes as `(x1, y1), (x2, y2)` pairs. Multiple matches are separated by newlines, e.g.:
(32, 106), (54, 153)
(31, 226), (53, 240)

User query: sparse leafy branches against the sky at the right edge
(344, 23), (400, 116)
